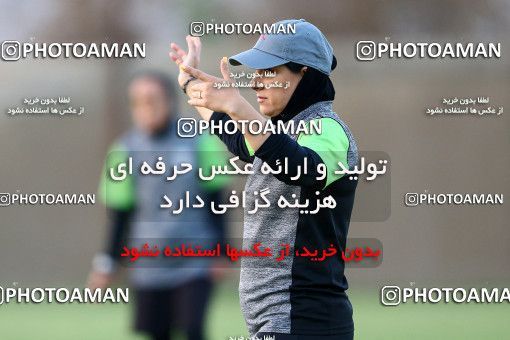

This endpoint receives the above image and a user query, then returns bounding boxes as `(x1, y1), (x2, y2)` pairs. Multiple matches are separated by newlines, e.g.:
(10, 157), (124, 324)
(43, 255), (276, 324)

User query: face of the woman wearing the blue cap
(254, 65), (305, 117)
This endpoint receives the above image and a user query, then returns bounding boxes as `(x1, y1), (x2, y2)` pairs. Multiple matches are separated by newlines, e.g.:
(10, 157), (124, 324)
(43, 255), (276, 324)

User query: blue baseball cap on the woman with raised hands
(229, 19), (333, 76)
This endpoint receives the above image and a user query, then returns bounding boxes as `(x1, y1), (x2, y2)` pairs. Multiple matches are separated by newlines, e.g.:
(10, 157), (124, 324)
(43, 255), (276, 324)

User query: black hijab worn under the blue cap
(271, 56), (336, 122)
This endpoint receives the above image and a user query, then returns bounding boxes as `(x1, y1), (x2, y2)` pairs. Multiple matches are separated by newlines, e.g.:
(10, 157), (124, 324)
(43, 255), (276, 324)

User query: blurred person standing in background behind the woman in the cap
(88, 72), (226, 340)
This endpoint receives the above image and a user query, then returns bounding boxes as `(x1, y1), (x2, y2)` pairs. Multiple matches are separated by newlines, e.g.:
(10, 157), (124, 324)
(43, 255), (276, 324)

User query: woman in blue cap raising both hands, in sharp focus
(170, 19), (358, 340)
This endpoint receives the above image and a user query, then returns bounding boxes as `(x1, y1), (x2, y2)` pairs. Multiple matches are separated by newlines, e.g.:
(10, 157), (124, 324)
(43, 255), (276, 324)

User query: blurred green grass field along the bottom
(0, 283), (510, 340)
